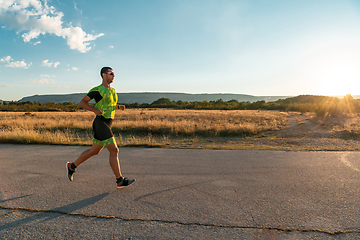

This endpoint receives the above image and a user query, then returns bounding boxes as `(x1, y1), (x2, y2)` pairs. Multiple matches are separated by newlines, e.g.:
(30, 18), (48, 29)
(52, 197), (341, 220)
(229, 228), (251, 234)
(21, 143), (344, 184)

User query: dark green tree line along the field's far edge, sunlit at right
(0, 95), (360, 117)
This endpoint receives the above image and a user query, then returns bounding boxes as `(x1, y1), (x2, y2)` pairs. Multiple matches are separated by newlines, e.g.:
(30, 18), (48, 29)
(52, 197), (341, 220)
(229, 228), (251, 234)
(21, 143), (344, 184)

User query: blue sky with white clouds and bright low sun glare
(0, 0), (360, 101)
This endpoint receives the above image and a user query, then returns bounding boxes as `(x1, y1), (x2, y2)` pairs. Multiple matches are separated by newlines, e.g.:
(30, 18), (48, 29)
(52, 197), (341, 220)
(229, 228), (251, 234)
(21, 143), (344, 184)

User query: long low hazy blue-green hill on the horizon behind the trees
(19, 92), (289, 104)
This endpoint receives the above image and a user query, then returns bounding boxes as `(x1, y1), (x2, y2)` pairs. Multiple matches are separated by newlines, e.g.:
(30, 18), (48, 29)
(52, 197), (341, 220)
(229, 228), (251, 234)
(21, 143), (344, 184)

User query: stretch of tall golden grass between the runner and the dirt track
(113, 109), (288, 137)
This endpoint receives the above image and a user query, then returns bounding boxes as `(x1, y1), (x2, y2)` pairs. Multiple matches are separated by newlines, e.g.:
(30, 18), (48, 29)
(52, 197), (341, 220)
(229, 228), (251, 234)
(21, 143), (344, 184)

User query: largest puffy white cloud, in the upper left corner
(0, 0), (104, 53)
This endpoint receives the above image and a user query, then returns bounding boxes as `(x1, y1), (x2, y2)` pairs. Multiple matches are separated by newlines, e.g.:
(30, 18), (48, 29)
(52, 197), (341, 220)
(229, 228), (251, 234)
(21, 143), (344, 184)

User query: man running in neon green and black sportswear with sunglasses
(66, 67), (135, 188)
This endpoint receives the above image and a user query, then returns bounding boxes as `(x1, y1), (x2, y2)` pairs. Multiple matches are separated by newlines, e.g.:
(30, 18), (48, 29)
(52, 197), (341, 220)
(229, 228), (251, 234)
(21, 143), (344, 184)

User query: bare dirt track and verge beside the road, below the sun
(249, 114), (360, 151)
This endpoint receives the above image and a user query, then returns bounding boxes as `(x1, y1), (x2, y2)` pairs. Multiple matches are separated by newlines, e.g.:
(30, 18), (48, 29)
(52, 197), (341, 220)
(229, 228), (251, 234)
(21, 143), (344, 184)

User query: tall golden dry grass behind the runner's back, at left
(0, 112), (92, 145)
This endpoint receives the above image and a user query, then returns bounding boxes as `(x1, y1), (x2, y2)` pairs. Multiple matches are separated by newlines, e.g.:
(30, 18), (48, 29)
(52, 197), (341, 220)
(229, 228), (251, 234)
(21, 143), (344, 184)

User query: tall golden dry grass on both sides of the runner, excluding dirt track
(0, 109), (289, 145)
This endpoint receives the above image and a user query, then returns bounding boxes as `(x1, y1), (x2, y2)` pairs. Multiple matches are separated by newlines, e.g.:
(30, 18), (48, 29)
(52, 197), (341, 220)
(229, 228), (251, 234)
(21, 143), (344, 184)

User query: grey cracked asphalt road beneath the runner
(0, 144), (360, 239)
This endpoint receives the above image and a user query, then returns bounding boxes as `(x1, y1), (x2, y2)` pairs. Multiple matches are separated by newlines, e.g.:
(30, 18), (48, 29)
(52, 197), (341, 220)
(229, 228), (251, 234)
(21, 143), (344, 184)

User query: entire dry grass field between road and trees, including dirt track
(0, 109), (360, 150)
